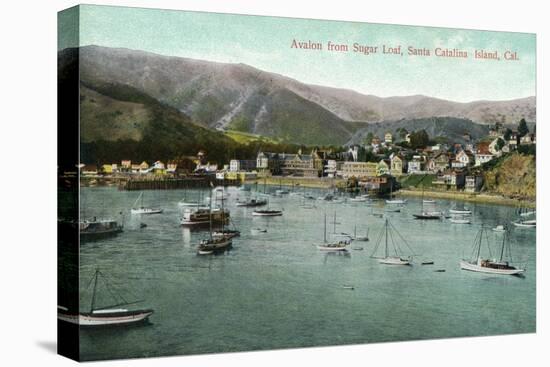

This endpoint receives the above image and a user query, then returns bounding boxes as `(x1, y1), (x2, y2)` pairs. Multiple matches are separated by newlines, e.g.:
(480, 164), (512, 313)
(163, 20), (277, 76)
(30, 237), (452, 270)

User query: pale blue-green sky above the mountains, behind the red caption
(59, 5), (536, 102)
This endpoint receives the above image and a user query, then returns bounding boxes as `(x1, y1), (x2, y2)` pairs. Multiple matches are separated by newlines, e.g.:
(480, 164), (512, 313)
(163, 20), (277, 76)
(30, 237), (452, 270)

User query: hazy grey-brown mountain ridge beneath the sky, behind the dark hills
(58, 46), (536, 145)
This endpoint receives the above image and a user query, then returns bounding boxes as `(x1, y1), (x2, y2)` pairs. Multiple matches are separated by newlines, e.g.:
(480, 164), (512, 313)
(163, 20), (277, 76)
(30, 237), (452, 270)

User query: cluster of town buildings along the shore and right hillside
(81, 129), (536, 196)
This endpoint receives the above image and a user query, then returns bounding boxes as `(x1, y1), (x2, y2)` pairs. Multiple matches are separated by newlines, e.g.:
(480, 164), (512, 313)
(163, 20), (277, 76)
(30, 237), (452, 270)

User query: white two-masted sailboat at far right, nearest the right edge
(460, 227), (525, 275)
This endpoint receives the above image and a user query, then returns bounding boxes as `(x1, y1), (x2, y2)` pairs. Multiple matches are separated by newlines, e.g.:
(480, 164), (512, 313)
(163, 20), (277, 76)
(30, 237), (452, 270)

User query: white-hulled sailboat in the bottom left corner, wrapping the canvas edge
(57, 268), (154, 326)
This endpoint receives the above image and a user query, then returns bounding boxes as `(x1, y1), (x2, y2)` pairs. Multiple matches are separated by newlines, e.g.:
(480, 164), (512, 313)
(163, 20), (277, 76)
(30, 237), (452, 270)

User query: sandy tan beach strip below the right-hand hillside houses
(394, 189), (536, 208)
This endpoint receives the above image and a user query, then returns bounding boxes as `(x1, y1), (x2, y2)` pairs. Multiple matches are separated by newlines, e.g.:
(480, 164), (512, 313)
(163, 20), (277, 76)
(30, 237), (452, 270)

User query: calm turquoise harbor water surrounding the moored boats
(80, 188), (536, 360)
